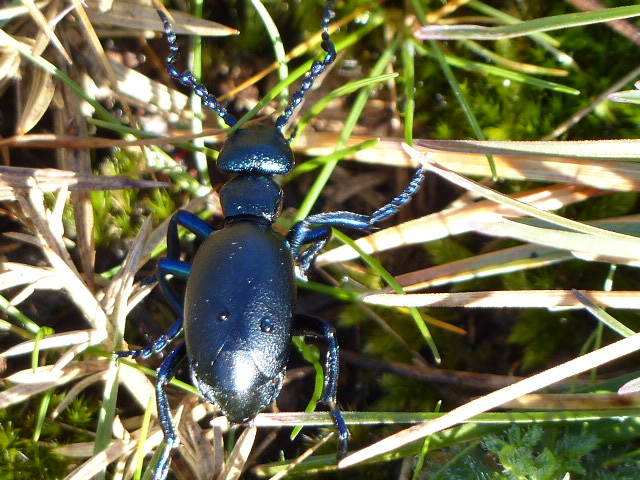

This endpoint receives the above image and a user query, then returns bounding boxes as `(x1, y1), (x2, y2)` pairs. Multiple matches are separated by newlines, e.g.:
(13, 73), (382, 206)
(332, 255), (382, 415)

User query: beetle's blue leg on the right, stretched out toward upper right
(287, 166), (424, 279)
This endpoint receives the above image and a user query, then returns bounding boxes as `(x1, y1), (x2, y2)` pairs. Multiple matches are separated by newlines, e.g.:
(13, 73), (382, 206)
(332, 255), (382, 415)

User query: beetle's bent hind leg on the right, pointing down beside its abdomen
(294, 313), (350, 460)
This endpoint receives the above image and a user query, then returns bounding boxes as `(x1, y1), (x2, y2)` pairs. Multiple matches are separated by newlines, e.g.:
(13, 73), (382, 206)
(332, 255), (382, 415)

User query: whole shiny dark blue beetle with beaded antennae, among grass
(118, 1), (424, 479)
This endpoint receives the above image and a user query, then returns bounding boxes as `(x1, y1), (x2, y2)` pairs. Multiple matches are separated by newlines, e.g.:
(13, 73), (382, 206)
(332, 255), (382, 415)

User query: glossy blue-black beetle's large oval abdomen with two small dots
(184, 222), (296, 422)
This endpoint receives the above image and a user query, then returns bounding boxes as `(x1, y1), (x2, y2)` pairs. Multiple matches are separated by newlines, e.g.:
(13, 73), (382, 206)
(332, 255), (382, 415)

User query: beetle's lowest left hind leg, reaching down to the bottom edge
(153, 342), (187, 480)
